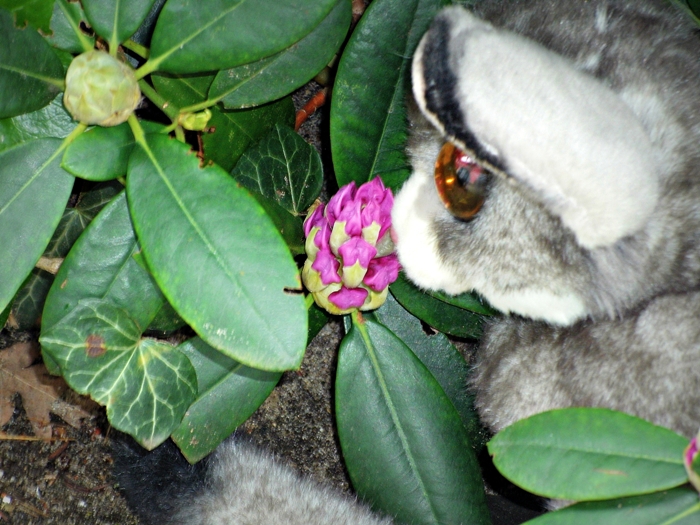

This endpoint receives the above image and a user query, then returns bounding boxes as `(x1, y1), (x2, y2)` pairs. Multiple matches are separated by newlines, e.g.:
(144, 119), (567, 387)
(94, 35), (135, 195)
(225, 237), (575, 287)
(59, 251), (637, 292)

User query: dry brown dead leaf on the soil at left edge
(0, 342), (95, 439)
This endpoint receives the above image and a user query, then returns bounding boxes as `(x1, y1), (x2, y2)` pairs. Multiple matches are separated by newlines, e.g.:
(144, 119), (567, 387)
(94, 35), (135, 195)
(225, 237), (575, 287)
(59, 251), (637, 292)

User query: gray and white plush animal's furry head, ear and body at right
(393, 0), (700, 437)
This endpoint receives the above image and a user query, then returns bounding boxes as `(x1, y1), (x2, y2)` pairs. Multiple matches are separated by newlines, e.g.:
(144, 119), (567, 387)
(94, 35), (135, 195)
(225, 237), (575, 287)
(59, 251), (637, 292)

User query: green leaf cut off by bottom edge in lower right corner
(527, 487), (700, 525)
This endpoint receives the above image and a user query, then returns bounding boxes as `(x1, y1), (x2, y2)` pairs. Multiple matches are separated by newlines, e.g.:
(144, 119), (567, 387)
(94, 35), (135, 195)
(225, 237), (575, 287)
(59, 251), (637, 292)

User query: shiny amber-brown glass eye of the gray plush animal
(435, 142), (488, 219)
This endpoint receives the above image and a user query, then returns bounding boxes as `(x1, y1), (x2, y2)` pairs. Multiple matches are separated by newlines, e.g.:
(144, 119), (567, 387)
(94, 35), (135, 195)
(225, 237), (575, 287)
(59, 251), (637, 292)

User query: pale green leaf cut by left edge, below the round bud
(0, 139), (73, 310)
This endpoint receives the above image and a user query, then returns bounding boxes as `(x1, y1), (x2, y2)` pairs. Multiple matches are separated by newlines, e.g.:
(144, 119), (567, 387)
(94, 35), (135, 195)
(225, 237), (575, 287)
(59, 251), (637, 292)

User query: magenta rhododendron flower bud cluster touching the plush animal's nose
(302, 177), (399, 314)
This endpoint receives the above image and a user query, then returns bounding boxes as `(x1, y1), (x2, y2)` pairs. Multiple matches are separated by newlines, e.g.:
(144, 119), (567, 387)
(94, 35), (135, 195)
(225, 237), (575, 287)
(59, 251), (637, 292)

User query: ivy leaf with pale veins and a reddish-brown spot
(40, 299), (197, 450)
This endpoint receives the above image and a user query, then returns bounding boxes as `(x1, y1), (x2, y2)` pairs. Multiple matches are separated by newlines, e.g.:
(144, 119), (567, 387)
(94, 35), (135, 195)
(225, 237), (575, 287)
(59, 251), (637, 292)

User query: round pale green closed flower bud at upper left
(63, 50), (141, 126)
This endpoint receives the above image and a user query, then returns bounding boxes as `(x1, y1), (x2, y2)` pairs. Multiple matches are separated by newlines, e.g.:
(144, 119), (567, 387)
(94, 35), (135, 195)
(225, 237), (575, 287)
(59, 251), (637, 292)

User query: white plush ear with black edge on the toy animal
(413, 8), (659, 248)
